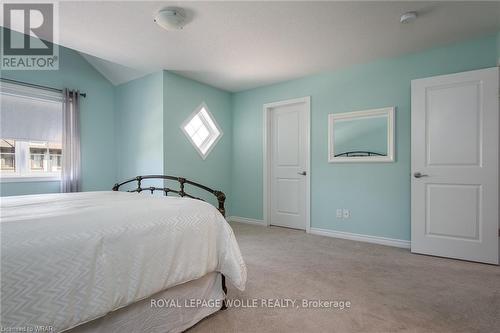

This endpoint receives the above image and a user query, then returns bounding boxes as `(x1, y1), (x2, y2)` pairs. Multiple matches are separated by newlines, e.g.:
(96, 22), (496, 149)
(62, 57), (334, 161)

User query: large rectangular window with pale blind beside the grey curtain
(0, 82), (62, 181)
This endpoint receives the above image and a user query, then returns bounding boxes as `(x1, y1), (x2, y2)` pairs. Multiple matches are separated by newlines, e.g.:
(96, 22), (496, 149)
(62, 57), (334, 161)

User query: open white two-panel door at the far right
(411, 68), (499, 264)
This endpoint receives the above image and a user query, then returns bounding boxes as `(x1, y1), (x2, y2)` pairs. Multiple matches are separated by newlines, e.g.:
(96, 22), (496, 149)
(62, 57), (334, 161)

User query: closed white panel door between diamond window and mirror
(268, 98), (309, 230)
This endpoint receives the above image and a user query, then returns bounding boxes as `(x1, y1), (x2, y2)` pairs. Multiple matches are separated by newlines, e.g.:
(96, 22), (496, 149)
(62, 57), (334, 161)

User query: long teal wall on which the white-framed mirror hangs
(230, 35), (497, 240)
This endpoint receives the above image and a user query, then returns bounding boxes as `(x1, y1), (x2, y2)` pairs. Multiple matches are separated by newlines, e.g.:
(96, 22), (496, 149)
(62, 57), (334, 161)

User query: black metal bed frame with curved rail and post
(113, 175), (227, 310)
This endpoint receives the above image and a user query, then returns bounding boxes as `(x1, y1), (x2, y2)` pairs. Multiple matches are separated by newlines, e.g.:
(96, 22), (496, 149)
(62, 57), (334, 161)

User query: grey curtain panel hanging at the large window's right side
(61, 89), (81, 192)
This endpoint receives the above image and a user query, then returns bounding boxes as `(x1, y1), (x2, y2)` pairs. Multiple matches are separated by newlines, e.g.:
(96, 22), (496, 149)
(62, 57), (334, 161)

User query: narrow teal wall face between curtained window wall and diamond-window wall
(115, 72), (163, 185)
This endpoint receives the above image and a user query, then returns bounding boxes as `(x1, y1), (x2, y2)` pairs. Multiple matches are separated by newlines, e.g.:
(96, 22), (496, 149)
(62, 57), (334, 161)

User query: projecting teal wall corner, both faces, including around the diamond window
(111, 71), (232, 203)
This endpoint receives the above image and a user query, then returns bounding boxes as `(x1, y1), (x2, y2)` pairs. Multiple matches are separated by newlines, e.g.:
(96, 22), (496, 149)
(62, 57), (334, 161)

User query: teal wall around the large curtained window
(0, 40), (116, 196)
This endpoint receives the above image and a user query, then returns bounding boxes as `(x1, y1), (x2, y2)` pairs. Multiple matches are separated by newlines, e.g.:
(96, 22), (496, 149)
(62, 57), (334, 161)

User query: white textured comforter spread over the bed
(0, 192), (246, 332)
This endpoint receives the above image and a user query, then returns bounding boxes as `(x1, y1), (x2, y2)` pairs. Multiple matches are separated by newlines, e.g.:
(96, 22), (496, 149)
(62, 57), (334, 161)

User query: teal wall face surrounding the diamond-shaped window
(163, 71), (233, 209)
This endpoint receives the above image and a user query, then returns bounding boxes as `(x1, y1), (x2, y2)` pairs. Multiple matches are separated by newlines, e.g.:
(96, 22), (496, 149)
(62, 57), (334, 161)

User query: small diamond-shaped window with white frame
(181, 103), (222, 159)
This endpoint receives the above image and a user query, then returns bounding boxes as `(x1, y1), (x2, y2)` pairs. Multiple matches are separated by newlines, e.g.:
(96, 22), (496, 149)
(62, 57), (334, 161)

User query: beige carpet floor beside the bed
(189, 223), (500, 333)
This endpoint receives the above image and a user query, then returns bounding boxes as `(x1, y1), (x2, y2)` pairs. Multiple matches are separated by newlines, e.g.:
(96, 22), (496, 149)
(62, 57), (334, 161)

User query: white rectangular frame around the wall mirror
(328, 107), (395, 163)
